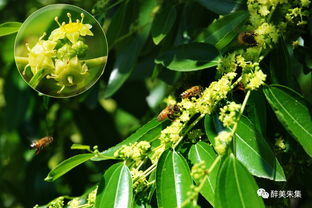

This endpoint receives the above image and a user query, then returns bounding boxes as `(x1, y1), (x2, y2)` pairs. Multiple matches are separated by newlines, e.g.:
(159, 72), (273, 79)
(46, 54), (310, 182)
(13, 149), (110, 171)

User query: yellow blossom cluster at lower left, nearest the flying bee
(114, 141), (151, 164)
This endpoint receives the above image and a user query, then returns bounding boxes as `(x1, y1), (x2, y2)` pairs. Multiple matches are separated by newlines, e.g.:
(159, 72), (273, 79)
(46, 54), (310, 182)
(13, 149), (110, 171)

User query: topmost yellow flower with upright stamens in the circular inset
(49, 13), (93, 43)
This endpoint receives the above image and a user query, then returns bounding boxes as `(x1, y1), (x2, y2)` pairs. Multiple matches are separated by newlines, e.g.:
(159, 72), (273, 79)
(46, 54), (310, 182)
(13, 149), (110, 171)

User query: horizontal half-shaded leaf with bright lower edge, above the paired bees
(155, 42), (219, 72)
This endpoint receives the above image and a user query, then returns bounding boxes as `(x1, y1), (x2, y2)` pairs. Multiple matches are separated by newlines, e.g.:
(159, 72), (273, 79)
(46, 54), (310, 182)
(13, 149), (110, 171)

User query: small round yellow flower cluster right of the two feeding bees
(219, 102), (241, 127)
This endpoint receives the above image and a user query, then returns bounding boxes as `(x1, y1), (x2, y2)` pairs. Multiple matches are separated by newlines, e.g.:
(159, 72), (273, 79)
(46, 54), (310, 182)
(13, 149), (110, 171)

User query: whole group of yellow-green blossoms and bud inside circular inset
(23, 13), (93, 93)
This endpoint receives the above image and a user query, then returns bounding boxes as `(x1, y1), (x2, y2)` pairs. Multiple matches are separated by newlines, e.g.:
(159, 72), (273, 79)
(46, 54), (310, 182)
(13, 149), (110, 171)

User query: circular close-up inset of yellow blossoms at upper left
(14, 4), (108, 98)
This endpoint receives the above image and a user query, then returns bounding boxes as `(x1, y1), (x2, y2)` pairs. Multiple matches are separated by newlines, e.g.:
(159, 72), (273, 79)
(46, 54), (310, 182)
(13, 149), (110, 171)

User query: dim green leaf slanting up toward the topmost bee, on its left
(201, 11), (249, 50)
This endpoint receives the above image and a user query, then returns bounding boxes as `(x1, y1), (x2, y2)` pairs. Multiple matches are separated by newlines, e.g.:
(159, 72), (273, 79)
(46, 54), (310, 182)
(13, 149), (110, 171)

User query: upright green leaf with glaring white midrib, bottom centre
(156, 150), (192, 208)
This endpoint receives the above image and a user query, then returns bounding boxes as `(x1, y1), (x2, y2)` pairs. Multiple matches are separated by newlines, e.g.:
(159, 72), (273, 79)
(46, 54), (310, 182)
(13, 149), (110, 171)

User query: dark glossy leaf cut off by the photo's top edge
(196, 0), (245, 14)
